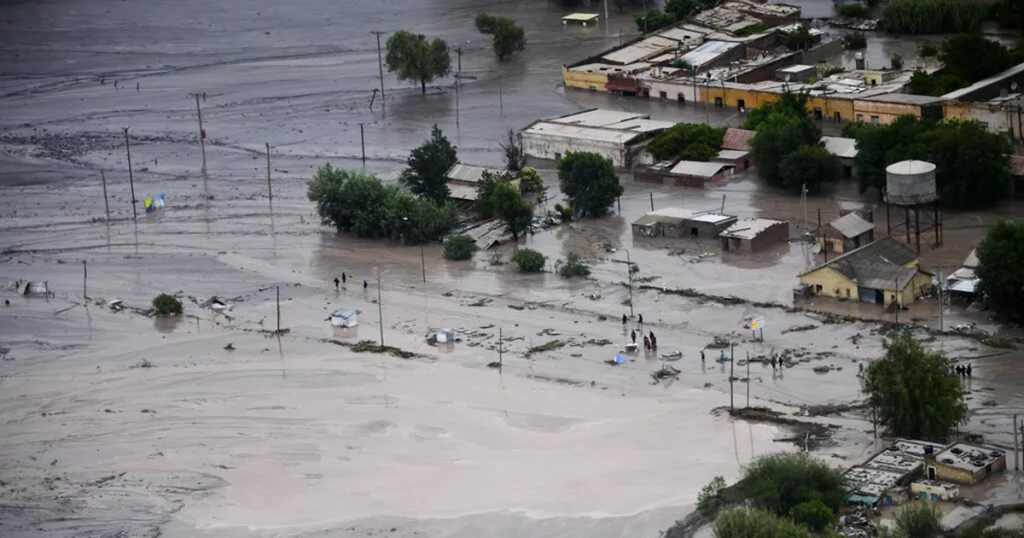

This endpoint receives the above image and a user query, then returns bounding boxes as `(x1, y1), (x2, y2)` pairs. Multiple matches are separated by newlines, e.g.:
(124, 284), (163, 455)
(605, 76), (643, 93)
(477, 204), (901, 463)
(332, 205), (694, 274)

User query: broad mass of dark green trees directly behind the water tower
(843, 116), (1012, 209)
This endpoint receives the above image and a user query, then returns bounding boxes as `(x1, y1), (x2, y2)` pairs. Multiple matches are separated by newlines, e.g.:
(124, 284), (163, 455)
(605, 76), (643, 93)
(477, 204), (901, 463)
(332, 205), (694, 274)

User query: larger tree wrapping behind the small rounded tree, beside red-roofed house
(751, 112), (821, 192)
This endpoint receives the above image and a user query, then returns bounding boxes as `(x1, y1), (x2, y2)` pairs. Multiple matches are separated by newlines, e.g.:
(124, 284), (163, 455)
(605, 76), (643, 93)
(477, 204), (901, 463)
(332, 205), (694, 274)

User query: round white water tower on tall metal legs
(883, 161), (942, 253)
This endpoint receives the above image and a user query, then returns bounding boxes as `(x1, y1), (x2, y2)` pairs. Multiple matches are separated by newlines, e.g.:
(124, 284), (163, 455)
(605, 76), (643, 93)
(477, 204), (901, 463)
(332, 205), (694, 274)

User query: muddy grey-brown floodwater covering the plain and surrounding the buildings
(0, 0), (1022, 537)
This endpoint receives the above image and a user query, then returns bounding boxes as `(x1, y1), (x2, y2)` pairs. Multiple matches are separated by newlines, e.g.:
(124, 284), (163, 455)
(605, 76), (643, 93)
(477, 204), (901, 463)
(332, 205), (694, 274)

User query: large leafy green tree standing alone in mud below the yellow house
(864, 333), (967, 441)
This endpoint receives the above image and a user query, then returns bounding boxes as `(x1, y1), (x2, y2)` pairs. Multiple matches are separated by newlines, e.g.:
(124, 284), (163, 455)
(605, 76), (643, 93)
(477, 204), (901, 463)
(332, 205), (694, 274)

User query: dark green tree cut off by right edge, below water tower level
(975, 219), (1024, 323)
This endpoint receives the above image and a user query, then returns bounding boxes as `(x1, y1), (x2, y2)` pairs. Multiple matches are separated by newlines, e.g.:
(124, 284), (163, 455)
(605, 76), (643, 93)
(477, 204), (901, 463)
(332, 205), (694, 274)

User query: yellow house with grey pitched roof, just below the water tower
(800, 237), (932, 304)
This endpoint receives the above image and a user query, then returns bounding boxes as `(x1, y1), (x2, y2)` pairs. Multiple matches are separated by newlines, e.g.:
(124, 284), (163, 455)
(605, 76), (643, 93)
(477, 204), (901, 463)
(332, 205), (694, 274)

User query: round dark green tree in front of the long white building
(558, 152), (623, 217)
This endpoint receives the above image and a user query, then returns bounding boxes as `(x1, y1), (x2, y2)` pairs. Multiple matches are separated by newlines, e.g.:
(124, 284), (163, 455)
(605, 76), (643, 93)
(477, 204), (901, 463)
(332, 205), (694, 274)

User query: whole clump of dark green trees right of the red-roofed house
(743, 91), (839, 194)
